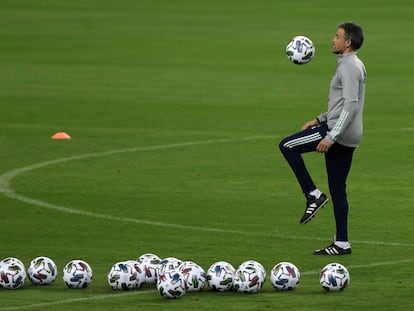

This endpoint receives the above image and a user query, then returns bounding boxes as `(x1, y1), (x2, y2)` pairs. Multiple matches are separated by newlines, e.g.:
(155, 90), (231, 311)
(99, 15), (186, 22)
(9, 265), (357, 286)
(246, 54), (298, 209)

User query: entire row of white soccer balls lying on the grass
(0, 254), (350, 298)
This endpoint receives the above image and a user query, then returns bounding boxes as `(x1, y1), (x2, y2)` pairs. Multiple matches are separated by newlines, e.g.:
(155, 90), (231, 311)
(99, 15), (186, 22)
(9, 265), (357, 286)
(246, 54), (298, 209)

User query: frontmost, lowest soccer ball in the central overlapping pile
(157, 270), (186, 298)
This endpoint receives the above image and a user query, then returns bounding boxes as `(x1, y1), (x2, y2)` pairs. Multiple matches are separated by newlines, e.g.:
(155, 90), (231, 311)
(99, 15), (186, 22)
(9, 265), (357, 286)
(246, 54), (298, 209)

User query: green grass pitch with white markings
(0, 0), (414, 311)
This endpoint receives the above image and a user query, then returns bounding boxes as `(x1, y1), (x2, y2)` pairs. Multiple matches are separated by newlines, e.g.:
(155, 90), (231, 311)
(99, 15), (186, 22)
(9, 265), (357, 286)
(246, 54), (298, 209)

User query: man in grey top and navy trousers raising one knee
(279, 22), (367, 255)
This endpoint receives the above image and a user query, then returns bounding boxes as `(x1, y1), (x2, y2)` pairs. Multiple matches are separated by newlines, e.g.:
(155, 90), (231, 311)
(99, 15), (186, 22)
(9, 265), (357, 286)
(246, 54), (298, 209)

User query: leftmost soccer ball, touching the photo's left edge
(0, 257), (26, 289)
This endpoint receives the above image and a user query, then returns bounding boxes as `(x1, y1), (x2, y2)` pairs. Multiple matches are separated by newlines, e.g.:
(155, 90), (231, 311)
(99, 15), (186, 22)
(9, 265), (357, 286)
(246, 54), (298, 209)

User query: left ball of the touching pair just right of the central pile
(207, 261), (236, 292)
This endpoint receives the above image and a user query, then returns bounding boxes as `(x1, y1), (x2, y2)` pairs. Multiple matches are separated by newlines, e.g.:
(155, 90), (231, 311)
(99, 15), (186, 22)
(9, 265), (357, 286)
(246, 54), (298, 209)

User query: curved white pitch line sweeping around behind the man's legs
(0, 136), (414, 247)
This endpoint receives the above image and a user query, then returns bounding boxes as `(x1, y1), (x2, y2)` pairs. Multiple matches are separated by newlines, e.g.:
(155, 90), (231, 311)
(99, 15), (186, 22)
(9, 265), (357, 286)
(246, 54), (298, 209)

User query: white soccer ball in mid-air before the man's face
(286, 36), (315, 65)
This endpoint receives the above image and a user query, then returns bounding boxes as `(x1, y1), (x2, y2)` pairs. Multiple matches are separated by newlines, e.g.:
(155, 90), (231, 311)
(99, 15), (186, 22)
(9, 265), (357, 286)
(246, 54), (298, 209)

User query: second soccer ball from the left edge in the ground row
(27, 256), (58, 285)
